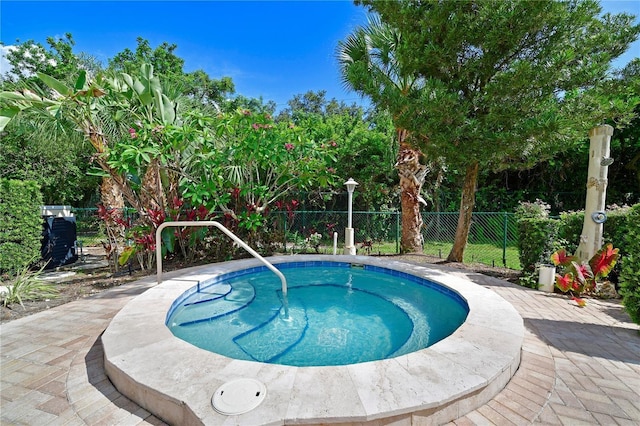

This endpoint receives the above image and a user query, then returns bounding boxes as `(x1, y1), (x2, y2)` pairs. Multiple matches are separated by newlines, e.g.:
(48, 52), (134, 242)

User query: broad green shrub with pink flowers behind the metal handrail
(174, 110), (336, 216)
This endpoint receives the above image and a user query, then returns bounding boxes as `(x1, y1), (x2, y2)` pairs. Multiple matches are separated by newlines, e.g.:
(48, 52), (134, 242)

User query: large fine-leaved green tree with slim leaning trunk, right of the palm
(361, 0), (640, 262)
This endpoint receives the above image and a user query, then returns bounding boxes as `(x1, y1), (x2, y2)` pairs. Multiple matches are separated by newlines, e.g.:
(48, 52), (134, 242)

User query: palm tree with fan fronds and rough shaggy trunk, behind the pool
(337, 15), (427, 253)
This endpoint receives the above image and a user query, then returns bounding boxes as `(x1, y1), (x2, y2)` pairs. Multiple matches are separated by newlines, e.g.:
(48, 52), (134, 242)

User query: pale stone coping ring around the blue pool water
(102, 255), (524, 425)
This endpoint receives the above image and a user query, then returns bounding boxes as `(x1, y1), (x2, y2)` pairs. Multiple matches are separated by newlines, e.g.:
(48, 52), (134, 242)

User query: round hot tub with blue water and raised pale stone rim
(102, 256), (524, 425)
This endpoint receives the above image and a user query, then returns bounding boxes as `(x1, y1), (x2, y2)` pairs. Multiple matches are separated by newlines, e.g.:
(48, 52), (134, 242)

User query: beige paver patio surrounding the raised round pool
(0, 262), (640, 426)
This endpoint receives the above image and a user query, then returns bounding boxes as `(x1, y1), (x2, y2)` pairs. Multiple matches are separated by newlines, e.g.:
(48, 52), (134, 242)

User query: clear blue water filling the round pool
(166, 262), (469, 366)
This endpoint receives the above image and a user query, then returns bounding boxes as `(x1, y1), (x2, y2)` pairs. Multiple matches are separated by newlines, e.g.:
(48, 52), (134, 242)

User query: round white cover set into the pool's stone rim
(211, 379), (267, 416)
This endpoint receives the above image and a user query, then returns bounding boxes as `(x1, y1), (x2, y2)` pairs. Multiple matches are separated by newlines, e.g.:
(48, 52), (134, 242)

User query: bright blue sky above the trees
(0, 0), (640, 112)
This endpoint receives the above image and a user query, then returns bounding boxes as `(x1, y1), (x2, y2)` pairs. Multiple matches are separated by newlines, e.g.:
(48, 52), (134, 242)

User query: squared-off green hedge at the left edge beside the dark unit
(0, 179), (42, 274)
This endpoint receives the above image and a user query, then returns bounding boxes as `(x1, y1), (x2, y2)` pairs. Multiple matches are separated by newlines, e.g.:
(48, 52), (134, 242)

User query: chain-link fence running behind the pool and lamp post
(73, 209), (520, 269)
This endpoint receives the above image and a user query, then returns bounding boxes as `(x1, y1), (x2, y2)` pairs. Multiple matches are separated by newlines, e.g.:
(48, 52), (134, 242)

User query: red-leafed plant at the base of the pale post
(551, 244), (619, 307)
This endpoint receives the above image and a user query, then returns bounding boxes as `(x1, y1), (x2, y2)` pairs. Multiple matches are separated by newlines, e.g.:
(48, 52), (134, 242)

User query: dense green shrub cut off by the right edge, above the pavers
(620, 204), (640, 324)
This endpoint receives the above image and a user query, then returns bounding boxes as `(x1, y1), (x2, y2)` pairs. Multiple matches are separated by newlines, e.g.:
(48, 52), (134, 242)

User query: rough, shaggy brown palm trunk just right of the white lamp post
(396, 130), (427, 253)
